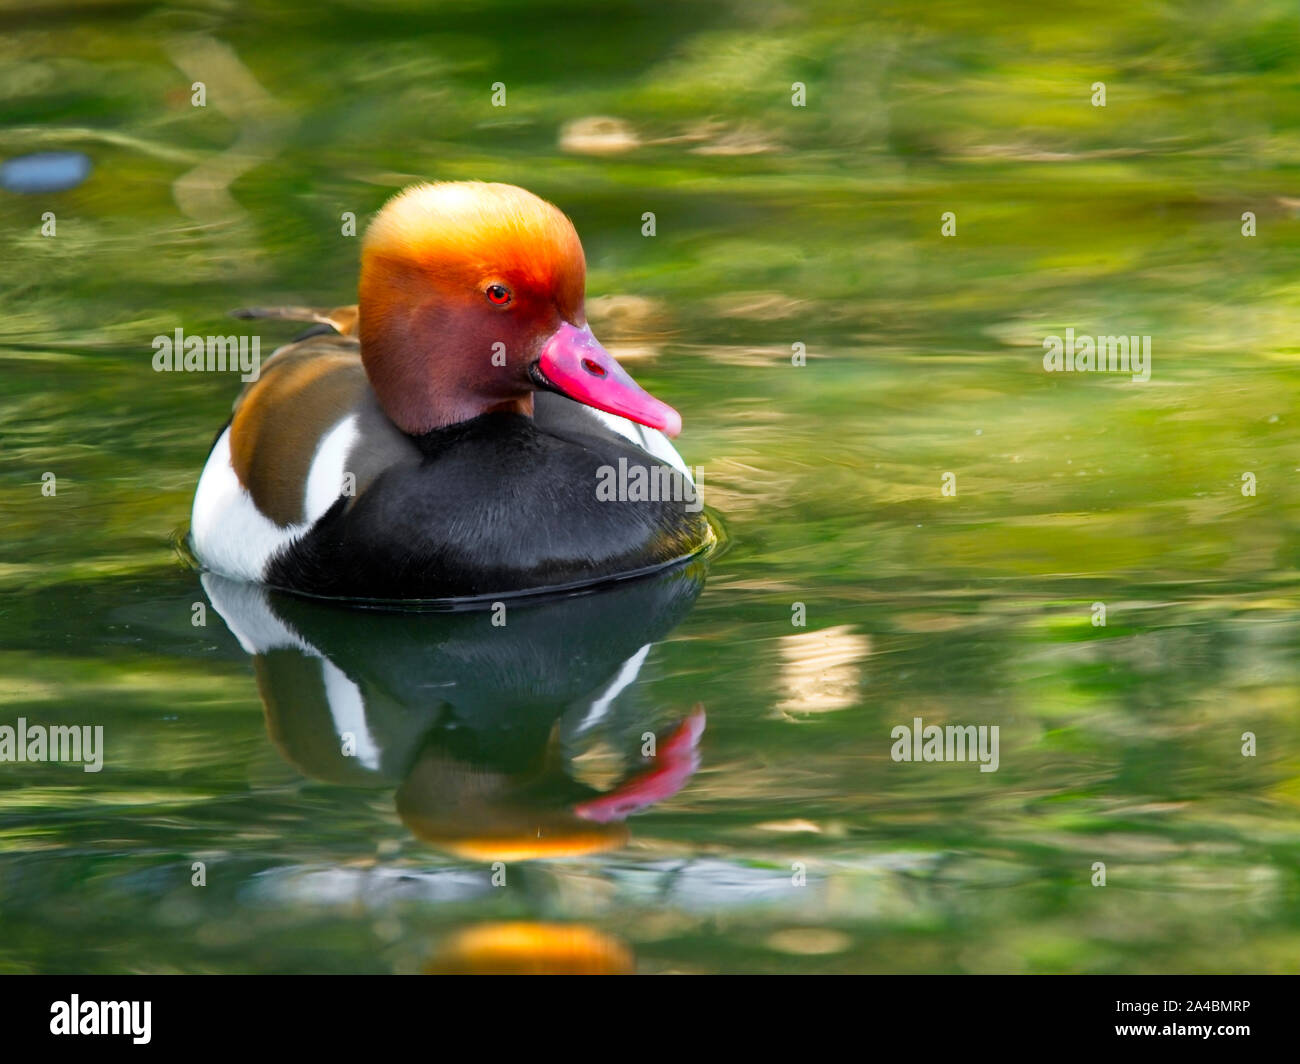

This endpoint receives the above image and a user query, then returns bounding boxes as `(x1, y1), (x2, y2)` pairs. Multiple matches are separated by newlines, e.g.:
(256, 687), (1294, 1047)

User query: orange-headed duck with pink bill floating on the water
(190, 181), (714, 602)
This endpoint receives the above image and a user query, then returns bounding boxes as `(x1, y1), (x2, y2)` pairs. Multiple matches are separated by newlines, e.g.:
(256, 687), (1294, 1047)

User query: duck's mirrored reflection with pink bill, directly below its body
(203, 563), (705, 861)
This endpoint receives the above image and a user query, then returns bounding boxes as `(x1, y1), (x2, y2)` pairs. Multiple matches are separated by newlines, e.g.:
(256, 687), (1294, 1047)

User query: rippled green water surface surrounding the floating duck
(0, 0), (1300, 972)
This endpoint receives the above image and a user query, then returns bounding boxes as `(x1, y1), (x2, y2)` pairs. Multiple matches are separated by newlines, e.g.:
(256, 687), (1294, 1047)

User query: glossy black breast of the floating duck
(267, 414), (709, 598)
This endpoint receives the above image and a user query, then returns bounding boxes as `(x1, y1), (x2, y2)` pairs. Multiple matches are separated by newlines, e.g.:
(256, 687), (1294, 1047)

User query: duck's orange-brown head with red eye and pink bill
(360, 181), (681, 436)
